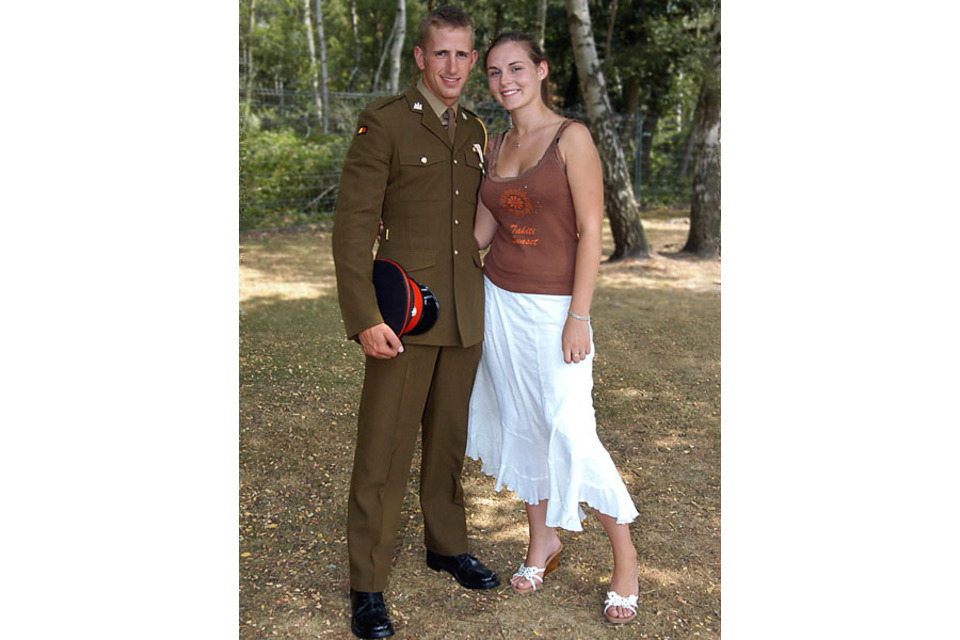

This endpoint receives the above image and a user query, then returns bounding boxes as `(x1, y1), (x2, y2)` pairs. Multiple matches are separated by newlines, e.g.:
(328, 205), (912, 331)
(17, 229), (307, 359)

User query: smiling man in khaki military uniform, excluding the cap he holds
(333, 7), (500, 638)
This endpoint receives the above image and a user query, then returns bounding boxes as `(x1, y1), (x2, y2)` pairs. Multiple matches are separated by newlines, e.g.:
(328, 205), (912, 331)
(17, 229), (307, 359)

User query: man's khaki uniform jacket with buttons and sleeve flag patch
(333, 87), (486, 347)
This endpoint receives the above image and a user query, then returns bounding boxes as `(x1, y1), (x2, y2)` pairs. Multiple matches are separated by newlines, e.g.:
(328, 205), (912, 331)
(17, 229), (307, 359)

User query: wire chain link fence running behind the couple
(240, 87), (692, 231)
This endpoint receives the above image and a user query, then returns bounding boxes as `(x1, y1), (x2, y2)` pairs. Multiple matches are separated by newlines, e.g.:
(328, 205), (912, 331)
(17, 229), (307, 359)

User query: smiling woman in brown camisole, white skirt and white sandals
(467, 32), (639, 623)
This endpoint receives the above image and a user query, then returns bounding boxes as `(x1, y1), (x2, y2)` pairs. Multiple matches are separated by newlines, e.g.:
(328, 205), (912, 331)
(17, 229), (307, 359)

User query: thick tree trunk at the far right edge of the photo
(682, 16), (720, 258)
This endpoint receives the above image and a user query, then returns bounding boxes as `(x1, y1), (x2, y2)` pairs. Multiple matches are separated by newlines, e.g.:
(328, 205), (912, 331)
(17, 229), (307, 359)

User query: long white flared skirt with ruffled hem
(466, 277), (638, 531)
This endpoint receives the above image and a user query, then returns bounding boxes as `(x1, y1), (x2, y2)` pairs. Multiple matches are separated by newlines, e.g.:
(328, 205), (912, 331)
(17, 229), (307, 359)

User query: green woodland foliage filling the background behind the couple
(239, 0), (719, 229)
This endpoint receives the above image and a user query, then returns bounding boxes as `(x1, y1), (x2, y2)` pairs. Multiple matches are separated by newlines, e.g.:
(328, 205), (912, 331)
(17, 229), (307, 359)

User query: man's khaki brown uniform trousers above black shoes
(347, 344), (480, 592)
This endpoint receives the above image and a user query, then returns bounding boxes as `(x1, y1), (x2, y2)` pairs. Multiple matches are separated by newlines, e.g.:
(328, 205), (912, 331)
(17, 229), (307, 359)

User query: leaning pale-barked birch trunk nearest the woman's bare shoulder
(566, 0), (650, 262)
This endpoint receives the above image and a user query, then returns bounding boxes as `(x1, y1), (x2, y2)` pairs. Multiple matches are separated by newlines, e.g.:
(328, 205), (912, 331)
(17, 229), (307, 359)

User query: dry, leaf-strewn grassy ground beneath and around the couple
(239, 211), (720, 640)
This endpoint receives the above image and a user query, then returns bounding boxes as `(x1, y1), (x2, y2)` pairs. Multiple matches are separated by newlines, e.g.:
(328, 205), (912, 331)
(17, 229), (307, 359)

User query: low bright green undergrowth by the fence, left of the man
(240, 128), (350, 230)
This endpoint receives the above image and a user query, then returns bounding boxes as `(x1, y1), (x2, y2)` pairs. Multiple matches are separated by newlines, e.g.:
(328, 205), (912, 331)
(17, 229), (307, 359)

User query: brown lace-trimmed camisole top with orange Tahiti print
(480, 120), (578, 295)
